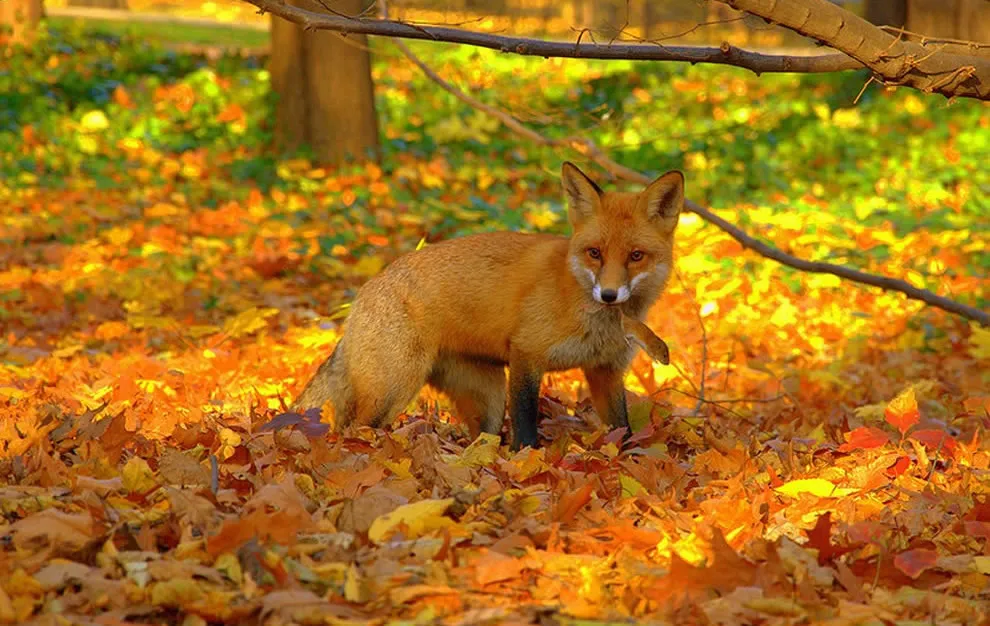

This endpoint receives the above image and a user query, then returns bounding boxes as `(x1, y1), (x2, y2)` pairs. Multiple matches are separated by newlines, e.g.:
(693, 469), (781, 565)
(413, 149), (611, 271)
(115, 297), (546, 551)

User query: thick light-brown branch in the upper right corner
(719, 0), (990, 100)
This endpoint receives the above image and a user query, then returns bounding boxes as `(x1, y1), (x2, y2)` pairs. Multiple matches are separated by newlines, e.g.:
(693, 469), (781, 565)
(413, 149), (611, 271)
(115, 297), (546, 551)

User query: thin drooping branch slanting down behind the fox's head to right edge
(379, 6), (990, 326)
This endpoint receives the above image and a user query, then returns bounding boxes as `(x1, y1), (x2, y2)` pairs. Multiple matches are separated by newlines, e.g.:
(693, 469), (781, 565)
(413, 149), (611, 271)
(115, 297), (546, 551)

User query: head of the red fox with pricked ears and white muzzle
(561, 162), (684, 305)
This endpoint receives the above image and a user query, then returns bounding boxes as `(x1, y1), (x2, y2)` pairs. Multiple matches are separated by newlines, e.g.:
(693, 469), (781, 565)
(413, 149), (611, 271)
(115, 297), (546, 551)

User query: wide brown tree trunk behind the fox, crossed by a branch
(270, 0), (378, 164)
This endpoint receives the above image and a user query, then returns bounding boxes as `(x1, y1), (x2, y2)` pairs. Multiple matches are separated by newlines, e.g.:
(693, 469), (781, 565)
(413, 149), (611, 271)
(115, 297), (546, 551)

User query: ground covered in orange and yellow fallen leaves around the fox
(0, 22), (990, 625)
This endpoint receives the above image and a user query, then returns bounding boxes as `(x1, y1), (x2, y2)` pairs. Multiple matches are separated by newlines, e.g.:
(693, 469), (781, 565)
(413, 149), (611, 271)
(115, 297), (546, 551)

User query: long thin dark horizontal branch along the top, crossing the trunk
(245, 0), (863, 74)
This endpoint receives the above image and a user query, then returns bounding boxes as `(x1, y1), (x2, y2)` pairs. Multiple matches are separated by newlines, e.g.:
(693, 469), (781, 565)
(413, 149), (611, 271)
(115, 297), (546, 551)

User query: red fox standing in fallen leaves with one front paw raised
(292, 162), (684, 450)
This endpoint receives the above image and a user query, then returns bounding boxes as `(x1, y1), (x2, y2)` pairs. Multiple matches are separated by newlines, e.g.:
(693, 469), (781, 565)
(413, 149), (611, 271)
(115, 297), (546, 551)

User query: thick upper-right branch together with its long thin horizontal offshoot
(245, 0), (990, 100)
